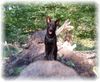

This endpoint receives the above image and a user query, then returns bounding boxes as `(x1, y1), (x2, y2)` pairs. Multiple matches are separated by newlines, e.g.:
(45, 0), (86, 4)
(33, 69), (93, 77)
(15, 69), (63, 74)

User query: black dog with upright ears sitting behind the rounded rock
(44, 17), (59, 60)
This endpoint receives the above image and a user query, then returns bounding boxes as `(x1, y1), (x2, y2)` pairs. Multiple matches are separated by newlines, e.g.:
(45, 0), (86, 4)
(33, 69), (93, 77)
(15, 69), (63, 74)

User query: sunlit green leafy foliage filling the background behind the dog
(4, 3), (96, 50)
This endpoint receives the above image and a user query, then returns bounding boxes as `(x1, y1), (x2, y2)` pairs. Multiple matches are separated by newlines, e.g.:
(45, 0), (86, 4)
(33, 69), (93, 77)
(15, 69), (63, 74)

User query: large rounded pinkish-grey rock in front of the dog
(17, 60), (78, 79)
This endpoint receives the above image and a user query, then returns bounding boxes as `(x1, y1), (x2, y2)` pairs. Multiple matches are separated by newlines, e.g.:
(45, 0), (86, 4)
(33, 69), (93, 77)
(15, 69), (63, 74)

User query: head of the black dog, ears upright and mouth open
(46, 16), (59, 36)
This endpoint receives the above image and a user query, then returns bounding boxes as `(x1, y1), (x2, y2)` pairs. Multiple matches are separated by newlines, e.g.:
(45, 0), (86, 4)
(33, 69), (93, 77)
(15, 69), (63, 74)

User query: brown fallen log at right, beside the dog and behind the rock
(59, 49), (96, 77)
